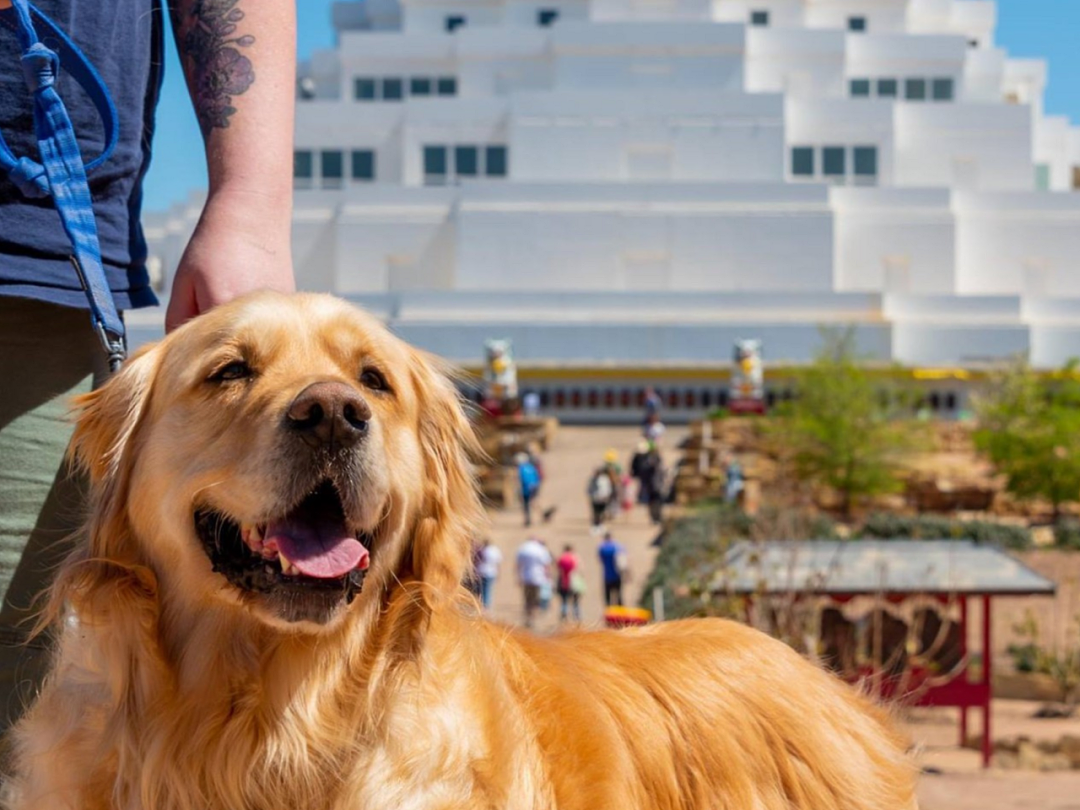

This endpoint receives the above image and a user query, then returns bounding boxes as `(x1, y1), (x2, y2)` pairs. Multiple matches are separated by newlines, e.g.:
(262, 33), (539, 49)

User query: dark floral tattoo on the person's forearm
(180, 0), (255, 137)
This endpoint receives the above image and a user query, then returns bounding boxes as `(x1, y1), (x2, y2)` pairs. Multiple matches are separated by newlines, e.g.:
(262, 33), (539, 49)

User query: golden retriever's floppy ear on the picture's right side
(413, 351), (484, 593)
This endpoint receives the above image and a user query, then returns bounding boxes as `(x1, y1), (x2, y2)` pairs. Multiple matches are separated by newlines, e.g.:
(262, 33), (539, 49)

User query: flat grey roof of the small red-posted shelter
(713, 540), (1056, 595)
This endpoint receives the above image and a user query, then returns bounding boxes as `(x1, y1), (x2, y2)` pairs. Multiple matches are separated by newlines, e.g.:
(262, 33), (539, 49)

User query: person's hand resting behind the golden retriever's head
(164, 189), (296, 332)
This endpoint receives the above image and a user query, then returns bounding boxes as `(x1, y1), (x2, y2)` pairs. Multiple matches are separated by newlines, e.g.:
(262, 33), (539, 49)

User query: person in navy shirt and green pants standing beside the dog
(0, 0), (296, 731)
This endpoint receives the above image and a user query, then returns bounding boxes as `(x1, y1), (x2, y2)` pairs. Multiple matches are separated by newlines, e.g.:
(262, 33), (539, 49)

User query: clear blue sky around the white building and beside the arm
(144, 0), (1080, 211)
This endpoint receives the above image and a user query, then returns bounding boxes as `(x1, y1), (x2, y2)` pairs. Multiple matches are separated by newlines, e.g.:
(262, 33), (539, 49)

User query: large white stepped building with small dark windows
(147, 0), (1080, 414)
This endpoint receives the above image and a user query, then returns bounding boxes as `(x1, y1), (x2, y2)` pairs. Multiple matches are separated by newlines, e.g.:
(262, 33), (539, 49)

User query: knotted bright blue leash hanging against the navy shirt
(0, 0), (127, 372)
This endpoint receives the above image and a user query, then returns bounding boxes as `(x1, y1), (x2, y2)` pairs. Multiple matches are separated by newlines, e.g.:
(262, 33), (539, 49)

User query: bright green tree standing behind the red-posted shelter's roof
(770, 329), (920, 514)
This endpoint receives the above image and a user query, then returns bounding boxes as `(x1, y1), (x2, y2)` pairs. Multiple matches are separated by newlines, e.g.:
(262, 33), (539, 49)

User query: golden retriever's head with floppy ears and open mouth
(61, 293), (480, 631)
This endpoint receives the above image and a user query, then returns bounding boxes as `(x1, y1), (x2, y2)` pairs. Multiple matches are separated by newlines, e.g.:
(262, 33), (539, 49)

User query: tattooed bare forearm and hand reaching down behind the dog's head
(165, 0), (296, 329)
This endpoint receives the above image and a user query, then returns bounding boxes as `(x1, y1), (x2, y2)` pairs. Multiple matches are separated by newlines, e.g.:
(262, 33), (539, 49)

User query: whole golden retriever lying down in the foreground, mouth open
(10, 294), (915, 810)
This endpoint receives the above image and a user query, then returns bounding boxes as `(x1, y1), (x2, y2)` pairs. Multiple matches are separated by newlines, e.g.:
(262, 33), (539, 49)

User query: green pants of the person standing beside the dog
(0, 295), (108, 732)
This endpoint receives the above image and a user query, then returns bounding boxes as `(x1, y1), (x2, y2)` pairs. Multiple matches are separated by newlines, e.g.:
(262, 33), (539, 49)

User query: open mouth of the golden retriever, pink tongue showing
(194, 481), (372, 602)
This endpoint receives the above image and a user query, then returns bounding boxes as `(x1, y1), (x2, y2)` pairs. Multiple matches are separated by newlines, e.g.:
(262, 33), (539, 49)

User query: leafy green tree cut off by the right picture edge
(974, 360), (1080, 521)
